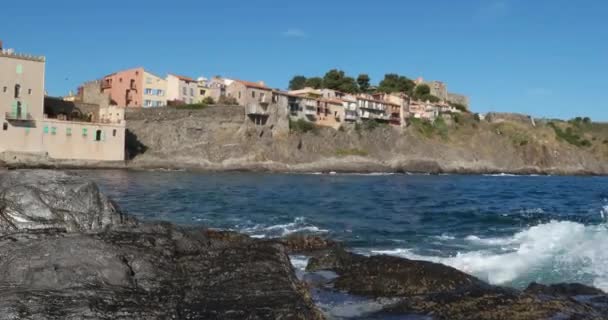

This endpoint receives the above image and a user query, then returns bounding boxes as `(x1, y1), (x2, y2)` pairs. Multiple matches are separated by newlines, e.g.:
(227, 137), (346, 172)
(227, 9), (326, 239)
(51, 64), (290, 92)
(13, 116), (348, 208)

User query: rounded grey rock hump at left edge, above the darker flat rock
(0, 171), (134, 234)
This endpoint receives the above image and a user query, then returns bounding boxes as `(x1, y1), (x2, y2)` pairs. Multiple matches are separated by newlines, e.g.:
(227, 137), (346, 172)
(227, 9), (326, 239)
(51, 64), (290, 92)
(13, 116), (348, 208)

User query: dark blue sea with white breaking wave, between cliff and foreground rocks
(78, 170), (608, 319)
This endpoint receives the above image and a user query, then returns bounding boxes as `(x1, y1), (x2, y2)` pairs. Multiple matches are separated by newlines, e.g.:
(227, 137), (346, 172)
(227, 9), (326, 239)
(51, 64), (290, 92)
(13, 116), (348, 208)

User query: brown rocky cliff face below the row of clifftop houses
(127, 106), (608, 174)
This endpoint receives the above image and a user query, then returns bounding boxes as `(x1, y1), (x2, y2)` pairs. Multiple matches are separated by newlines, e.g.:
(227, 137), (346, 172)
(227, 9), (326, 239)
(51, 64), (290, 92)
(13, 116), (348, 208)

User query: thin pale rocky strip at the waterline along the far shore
(0, 158), (608, 176)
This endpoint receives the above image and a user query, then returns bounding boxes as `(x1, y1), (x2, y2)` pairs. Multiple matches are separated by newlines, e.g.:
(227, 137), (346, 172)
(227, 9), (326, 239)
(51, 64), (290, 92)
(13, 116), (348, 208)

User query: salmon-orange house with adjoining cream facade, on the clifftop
(101, 68), (167, 108)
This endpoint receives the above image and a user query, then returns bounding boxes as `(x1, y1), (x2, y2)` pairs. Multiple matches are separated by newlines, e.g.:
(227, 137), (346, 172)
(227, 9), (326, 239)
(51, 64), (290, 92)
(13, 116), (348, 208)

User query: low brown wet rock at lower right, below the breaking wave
(307, 249), (608, 320)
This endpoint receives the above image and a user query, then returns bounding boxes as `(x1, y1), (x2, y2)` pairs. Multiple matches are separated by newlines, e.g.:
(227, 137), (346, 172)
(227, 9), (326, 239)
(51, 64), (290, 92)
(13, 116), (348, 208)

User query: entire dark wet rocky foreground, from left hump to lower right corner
(0, 171), (608, 319)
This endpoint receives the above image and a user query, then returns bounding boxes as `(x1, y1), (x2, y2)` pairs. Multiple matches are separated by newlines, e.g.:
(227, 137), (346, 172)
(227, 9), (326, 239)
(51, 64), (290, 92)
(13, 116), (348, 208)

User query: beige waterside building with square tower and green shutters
(0, 42), (126, 161)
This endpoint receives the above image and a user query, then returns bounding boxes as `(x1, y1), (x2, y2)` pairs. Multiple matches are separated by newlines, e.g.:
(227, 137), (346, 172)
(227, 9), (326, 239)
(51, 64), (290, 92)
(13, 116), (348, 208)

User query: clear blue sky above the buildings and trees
(0, 0), (608, 121)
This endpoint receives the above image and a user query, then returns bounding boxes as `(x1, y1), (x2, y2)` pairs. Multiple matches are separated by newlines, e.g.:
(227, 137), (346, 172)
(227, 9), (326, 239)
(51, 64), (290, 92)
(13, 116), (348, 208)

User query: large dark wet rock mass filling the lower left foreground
(0, 172), (322, 319)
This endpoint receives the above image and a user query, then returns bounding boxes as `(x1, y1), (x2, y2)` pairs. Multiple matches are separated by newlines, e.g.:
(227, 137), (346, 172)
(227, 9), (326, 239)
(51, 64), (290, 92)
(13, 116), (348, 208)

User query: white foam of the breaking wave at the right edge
(372, 221), (608, 290)
